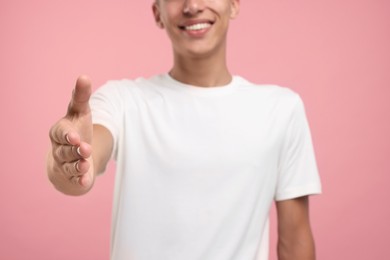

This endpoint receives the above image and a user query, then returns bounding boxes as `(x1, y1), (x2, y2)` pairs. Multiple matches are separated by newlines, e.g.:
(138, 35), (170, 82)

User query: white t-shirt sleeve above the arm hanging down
(275, 95), (321, 201)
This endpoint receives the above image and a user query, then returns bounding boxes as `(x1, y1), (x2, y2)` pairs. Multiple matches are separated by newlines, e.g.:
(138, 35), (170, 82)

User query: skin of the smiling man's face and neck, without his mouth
(153, 0), (240, 87)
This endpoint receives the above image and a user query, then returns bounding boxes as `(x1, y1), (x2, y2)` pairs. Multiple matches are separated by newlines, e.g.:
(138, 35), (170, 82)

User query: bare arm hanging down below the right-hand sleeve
(276, 196), (315, 260)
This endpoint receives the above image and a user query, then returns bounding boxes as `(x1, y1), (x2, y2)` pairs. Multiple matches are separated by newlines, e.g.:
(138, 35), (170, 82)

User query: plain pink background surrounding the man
(0, 0), (390, 260)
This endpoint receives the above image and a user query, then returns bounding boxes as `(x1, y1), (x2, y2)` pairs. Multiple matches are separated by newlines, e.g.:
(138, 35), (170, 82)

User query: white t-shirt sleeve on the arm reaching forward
(89, 81), (123, 159)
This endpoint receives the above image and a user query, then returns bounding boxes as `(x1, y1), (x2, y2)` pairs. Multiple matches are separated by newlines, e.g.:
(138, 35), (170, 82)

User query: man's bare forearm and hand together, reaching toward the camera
(47, 76), (113, 196)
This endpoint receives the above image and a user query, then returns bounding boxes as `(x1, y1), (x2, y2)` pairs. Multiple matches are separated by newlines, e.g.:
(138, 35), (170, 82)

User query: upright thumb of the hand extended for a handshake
(68, 76), (92, 115)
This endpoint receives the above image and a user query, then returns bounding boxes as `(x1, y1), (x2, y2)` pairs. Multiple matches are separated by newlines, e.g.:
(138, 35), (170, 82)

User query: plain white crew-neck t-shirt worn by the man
(91, 74), (321, 260)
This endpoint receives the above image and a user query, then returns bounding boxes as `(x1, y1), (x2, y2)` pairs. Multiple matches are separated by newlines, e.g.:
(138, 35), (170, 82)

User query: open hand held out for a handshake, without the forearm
(48, 76), (94, 194)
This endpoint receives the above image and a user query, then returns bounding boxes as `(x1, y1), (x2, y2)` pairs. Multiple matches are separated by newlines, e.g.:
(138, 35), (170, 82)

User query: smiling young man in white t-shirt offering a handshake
(47, 0), (321, 260)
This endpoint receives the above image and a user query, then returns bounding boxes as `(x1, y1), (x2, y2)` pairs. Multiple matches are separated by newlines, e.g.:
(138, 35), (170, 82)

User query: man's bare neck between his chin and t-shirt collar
(169, 47), (232, 87)
